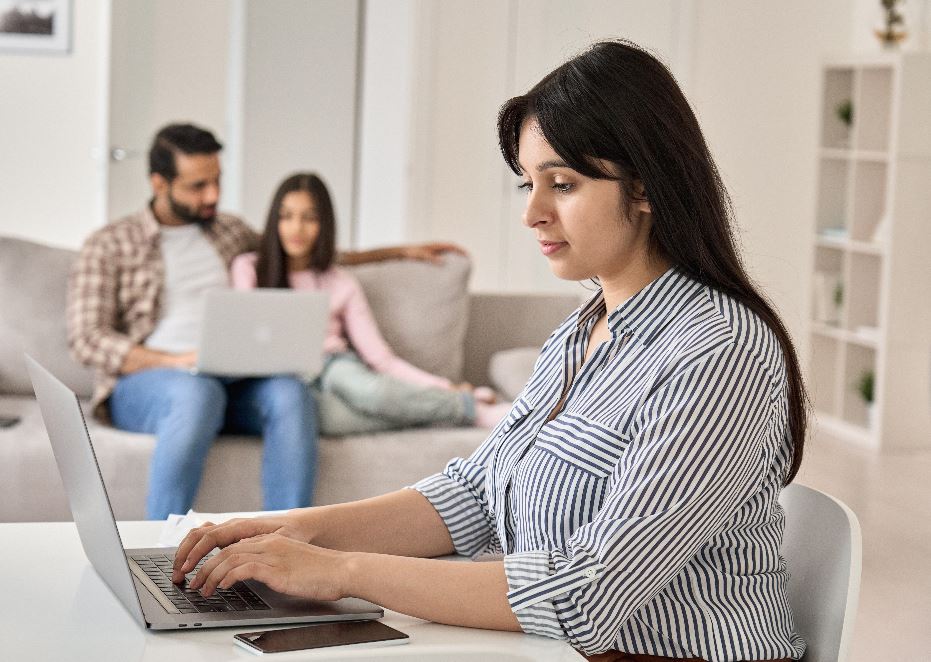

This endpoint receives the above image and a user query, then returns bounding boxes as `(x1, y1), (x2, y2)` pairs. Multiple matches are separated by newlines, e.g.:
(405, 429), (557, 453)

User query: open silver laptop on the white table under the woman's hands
(26, 355), (384, 630)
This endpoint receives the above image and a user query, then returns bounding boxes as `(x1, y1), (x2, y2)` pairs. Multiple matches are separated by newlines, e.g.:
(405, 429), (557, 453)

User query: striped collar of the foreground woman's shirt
(576, 267), (704, 345)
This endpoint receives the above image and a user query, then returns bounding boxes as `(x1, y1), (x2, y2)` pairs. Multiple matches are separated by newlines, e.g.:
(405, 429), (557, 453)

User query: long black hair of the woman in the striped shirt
(498, 41), (808, 484)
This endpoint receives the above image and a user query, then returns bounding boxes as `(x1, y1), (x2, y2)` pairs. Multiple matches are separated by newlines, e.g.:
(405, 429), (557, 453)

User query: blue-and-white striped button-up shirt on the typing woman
(414, 269), (805, 661)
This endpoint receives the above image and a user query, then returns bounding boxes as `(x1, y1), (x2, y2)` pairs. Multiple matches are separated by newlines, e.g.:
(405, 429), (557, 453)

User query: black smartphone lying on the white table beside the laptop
(233, 621), (410, 655)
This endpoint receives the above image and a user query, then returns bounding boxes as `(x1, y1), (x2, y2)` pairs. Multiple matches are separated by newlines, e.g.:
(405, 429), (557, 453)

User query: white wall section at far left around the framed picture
(0, 0), (109, 247)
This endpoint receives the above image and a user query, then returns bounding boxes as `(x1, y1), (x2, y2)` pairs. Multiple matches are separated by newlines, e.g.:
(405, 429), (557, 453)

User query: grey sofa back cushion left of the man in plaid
(0, 237), (93, 397)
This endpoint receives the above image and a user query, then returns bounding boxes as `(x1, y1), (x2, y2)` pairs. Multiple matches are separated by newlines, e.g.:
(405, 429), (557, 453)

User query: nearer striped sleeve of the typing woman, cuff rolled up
(505, 344), (783, 654)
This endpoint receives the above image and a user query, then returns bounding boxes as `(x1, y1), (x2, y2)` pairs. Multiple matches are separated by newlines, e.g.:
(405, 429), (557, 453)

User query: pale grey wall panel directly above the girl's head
(242, 0), (358, 244)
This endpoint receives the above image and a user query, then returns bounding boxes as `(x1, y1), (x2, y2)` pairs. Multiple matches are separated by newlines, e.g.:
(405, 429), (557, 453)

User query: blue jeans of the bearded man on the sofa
(110, 368), (317, 519)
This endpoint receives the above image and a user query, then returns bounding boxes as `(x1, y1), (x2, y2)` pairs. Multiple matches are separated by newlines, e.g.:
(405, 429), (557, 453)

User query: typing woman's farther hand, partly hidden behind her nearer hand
(171, 509), (313, 584)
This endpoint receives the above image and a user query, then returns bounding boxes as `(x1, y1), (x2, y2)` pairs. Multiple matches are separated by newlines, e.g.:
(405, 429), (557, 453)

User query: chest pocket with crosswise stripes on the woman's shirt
(534, 413), (630, 478)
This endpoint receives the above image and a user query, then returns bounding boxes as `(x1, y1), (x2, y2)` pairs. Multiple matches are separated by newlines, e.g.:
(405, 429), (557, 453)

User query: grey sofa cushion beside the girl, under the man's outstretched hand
(351, 253), (470, 381)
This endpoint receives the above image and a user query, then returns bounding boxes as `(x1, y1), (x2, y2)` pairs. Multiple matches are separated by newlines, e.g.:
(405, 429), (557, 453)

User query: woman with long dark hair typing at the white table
(175, 41), (807, 662)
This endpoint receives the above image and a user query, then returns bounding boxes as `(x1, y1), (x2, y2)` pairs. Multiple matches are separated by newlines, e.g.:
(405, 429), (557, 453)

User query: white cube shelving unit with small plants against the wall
(808, 53), (931, 449)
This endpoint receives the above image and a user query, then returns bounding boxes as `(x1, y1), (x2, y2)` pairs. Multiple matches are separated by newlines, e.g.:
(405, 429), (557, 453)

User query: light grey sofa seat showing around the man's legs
(0, 396), (488, 522)
